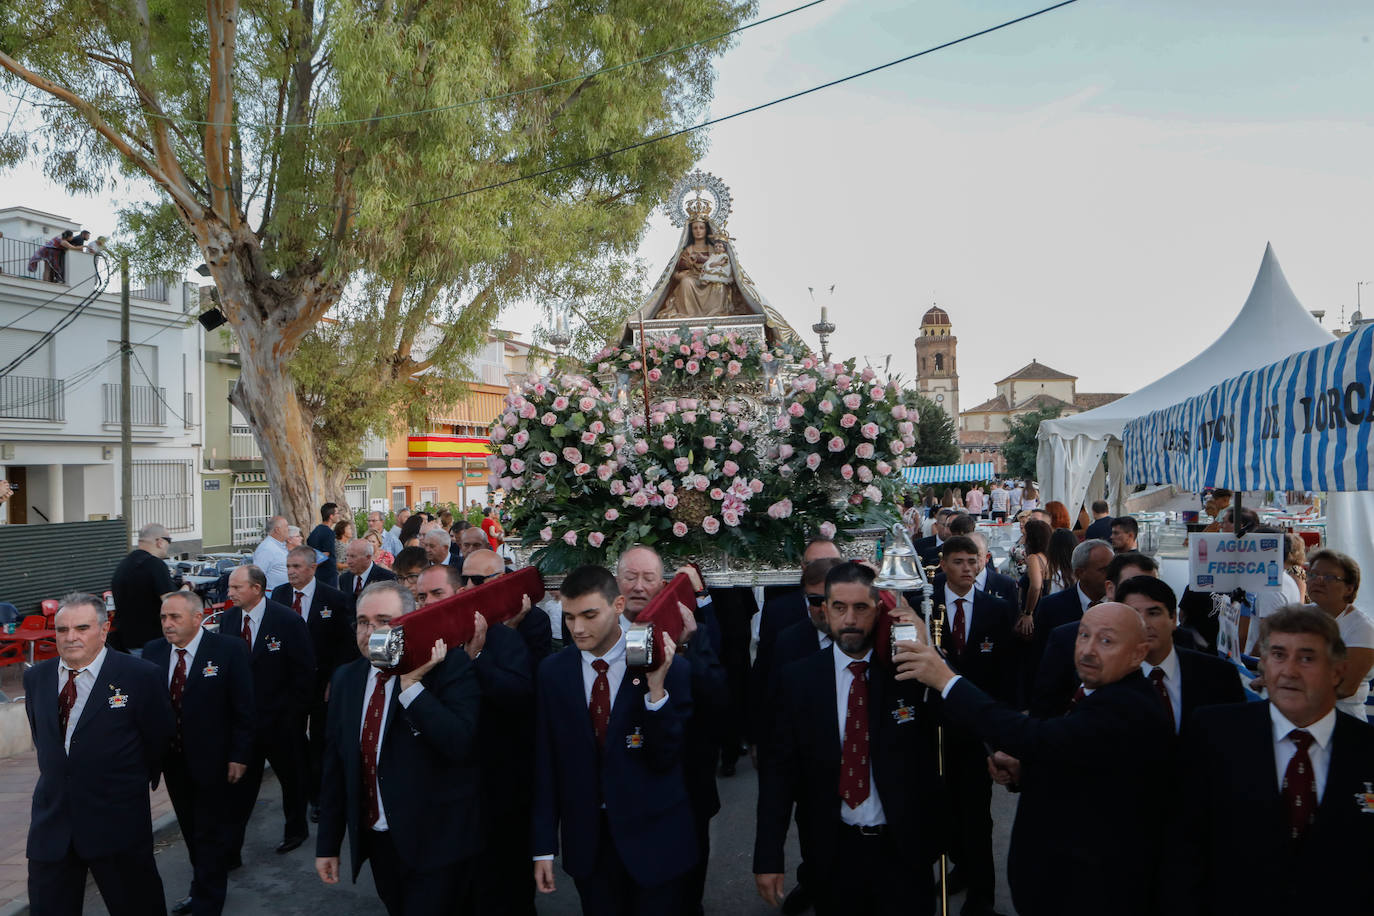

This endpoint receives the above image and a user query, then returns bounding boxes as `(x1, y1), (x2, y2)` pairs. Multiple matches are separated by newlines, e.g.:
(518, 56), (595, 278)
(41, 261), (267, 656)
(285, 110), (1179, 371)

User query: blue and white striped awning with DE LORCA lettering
(1123, 325), (1374, 490)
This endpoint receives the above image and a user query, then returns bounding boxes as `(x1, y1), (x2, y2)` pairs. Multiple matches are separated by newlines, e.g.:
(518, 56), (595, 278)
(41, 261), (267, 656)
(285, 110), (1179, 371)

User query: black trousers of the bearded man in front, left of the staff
(807, 824), (936, 916)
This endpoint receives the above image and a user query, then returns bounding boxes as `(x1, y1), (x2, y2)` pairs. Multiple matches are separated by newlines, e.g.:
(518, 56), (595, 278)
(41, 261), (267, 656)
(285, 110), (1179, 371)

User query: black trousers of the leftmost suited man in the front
(29, 843), (168, 916)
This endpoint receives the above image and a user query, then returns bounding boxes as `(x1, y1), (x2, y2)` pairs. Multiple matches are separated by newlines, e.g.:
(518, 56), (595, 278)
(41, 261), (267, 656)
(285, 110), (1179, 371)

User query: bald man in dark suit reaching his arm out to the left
(896, 604), (1173, 916)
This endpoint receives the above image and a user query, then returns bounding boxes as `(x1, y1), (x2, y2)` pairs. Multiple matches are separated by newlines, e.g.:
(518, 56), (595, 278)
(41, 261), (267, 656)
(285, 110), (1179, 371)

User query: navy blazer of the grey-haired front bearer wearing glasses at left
(315, 651), (482, 882)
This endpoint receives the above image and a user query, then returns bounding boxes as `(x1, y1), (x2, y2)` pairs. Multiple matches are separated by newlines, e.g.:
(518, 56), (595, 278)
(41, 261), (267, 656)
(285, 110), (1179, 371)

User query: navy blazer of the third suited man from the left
(220, 600), (315, 735)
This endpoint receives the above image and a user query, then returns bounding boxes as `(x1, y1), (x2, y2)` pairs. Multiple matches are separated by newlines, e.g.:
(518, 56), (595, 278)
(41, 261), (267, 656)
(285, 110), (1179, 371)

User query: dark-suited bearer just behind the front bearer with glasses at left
(415, 565), (533, 916)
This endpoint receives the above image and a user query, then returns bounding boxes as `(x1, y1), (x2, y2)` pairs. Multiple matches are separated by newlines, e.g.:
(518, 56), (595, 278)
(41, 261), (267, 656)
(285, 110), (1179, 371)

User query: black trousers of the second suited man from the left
(162, 754), (235, 916)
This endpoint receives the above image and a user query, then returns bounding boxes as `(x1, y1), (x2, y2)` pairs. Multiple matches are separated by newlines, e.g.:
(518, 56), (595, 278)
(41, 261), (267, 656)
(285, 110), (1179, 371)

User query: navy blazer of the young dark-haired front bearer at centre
(532, 645), (697, 887)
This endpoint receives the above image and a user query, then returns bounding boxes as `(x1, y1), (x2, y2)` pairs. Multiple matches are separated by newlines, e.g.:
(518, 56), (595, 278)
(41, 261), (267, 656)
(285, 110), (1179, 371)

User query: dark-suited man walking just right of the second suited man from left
(220, 566), (315, 871)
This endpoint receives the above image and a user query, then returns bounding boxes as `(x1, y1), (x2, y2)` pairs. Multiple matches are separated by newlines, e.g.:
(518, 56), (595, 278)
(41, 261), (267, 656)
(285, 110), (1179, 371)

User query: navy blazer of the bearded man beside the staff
(754, 648), (944, 880)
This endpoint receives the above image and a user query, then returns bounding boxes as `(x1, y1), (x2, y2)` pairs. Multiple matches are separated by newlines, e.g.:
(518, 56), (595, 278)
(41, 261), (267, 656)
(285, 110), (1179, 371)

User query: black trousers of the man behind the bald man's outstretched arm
(944, 728), (996, 913)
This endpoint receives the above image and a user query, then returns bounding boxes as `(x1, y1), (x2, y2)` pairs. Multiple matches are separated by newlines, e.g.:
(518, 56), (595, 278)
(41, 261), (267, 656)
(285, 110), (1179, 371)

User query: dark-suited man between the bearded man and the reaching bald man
(932, 536), (1017, 916)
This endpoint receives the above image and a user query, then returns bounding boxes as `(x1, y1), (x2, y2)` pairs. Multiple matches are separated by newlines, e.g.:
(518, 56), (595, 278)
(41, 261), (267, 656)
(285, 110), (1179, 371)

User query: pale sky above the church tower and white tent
(0, 0), (1374, 407)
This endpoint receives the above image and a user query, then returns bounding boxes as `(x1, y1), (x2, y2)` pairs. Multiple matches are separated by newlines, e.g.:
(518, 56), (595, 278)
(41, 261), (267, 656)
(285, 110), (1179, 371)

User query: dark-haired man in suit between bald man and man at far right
(1116, 575), (1245, 731)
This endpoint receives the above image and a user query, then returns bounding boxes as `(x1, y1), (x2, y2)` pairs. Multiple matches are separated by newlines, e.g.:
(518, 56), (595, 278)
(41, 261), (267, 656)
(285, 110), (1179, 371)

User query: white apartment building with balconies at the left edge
(0, 207), (203, 552)
